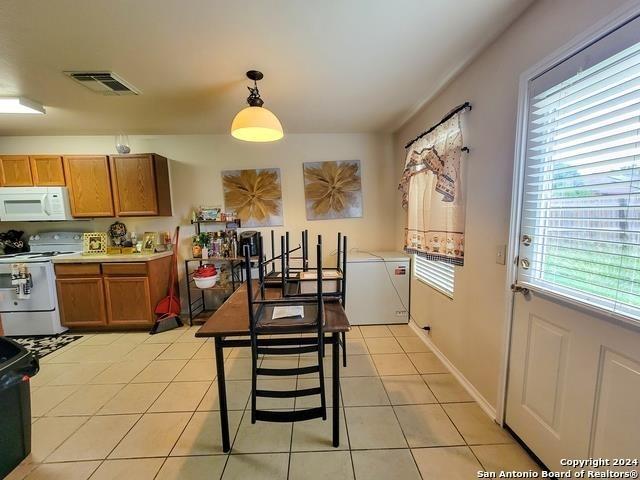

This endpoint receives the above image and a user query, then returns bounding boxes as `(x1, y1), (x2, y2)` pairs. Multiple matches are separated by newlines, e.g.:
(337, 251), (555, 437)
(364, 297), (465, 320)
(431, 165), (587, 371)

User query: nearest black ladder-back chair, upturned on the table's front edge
(244, 236), (327, 423)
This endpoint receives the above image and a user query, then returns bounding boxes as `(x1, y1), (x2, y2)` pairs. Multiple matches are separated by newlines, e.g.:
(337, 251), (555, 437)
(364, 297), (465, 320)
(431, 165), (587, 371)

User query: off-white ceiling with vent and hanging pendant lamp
(0, 0), (530, 135)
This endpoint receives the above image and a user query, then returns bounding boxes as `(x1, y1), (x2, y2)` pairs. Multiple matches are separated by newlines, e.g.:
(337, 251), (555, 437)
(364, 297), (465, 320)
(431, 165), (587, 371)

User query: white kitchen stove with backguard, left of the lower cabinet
(0, 232), (82, 336)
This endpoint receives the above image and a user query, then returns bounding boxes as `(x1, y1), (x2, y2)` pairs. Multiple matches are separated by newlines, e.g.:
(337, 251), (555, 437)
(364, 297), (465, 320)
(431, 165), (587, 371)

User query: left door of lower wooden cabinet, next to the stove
(56, 277), (107, 328)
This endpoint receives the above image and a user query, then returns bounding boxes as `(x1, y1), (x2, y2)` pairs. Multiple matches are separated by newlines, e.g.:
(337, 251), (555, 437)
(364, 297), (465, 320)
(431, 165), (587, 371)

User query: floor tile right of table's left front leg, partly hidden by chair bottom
(233, 410), (292, 453)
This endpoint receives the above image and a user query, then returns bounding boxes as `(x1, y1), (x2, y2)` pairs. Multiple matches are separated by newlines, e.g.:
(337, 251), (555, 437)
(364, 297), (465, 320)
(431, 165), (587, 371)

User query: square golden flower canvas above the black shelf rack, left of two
(222, 168), (283, 227)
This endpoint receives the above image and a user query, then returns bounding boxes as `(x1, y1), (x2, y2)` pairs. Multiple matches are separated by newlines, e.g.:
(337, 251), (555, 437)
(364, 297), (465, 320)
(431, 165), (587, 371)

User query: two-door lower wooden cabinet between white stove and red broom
(55, 256), (172, 330)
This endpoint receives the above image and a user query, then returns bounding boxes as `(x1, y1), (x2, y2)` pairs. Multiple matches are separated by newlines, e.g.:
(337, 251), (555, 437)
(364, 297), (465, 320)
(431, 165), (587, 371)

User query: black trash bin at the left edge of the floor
(0, 337), (39, 478)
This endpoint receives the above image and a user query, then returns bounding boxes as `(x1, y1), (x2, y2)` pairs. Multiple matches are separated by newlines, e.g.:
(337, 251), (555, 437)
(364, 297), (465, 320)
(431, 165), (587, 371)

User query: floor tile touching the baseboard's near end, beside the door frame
(442, 403), (513, 445)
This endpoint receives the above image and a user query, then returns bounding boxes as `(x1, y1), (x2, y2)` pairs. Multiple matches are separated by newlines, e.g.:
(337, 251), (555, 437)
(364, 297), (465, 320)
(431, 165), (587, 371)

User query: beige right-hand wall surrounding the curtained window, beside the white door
(394, 0), (625, 407)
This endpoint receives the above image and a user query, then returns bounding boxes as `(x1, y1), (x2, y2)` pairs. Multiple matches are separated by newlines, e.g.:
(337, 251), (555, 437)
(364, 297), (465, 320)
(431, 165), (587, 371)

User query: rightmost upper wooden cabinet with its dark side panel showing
(109, 153), (171, 217)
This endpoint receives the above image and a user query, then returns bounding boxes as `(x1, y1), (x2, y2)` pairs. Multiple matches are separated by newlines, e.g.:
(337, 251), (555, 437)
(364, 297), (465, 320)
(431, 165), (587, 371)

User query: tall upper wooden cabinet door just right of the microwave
(62, 155), (114, 217)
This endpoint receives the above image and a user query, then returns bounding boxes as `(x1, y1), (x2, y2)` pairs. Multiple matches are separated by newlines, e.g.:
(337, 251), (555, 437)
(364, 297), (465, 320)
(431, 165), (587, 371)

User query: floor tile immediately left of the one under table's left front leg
(109, 413), (191, 458)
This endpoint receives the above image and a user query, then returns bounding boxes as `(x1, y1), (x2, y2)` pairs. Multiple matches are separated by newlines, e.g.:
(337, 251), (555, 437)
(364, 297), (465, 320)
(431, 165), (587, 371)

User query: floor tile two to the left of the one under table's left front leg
(46, 415), (140, 462)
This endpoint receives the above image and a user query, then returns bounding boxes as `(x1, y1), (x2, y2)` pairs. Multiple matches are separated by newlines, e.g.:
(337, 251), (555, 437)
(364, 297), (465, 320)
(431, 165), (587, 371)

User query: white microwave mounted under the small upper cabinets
(0, 187), (73, 222)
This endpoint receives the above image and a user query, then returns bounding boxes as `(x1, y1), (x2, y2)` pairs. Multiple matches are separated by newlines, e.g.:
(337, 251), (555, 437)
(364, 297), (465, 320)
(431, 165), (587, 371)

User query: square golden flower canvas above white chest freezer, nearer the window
(302, 160), (362, 220)
